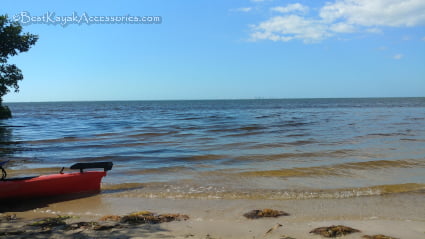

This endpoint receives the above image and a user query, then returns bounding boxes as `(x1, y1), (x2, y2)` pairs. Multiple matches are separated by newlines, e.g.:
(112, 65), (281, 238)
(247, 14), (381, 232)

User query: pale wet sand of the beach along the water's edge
(0, 192), (425, 239)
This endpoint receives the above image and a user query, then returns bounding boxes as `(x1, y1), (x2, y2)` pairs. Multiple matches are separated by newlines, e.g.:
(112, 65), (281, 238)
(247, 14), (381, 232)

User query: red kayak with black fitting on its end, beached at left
(0, 162), (113, 200)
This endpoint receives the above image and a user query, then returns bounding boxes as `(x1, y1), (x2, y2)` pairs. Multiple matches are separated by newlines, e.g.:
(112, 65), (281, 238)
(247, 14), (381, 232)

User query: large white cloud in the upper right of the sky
(251, 0), (425, 43)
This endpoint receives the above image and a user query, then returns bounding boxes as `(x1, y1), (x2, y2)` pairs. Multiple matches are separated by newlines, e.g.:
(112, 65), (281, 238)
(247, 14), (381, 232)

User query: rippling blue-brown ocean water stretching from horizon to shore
(0, 98), (425, 200)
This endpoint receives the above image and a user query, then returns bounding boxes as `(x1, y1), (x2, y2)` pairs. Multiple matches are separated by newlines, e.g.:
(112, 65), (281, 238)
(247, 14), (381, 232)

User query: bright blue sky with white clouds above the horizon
(0, 0), (425, 102)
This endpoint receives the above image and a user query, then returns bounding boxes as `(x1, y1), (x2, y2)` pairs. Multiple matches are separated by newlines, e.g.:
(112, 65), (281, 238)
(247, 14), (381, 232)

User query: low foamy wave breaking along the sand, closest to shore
(105, 183), (425, 200)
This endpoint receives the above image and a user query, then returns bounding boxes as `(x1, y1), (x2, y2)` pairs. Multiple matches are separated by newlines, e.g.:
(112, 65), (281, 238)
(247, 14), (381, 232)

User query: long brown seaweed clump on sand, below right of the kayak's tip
(117, 211), (189, 224)
